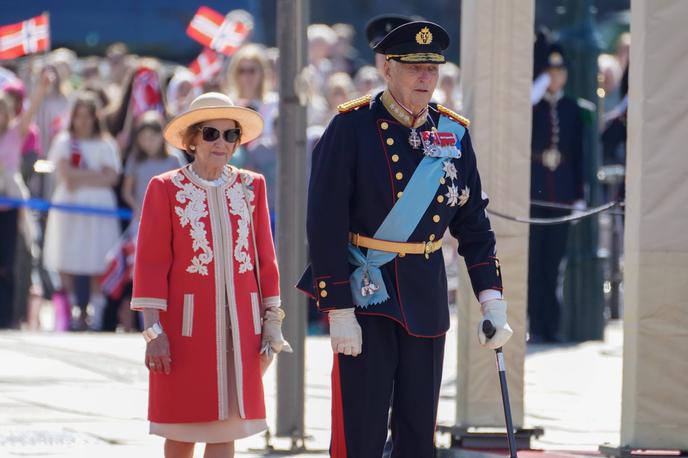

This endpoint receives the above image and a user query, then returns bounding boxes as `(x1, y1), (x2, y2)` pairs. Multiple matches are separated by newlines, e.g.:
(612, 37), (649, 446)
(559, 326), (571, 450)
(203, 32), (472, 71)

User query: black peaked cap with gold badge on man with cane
(373, 21), (449, 64)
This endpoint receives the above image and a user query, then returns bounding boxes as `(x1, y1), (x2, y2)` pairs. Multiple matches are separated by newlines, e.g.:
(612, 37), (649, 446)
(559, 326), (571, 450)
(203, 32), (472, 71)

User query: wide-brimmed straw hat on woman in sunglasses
(163, 92), (263, 149)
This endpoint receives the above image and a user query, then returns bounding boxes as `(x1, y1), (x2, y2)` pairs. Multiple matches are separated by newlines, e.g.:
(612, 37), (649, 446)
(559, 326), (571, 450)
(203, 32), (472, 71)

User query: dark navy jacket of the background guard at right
(530, 92), (583, 204)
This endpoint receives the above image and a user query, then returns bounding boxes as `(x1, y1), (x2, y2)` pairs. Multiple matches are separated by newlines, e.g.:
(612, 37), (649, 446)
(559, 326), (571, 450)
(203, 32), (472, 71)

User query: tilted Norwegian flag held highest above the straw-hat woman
(186, 6), (251, 56)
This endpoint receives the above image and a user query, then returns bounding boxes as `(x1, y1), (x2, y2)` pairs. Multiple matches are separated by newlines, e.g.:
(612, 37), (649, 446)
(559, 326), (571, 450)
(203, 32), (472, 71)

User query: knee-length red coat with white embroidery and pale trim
(131, 166), (280, 423)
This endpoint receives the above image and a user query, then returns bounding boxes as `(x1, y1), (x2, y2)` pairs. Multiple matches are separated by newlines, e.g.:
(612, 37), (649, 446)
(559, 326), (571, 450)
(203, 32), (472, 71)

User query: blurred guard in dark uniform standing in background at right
(528, 44), (585, 342)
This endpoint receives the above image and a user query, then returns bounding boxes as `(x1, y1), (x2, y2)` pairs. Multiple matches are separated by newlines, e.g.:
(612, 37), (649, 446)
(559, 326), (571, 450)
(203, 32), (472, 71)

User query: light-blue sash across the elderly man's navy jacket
(349, 115), (466, 308)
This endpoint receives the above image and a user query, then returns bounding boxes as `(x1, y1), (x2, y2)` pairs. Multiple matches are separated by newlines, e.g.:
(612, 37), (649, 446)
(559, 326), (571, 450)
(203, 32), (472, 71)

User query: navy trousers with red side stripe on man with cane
(330, 315), (445, 458)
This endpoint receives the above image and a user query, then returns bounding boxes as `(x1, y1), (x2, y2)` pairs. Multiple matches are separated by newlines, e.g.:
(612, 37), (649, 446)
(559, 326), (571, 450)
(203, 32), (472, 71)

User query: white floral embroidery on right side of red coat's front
(227, 173), (255, 274)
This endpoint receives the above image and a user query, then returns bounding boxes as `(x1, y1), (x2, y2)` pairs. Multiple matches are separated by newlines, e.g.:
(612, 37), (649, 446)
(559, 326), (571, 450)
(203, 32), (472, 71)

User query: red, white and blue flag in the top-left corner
(0, 13), (50, 59)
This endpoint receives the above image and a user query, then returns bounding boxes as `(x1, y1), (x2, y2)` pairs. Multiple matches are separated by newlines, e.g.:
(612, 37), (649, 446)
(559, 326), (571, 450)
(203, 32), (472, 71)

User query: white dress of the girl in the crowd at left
(44, 132), (122, 275)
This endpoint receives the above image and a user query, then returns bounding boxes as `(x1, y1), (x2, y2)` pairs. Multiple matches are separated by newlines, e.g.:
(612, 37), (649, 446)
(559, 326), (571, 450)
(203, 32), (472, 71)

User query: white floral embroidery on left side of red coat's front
(172, 173), (213, 275)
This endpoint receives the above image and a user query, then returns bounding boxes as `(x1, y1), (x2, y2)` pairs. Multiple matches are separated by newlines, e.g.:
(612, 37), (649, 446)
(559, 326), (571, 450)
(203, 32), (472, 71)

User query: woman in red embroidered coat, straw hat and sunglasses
(131, 93), (291, 457)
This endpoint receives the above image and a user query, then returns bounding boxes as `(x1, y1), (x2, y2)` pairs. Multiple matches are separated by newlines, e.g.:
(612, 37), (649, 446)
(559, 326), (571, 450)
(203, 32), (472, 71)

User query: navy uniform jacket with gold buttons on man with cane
(298, 95), (502, 337)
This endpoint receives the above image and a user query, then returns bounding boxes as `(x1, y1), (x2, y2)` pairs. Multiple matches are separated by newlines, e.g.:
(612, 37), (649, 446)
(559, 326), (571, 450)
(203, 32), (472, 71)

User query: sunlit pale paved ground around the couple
(0, 314), (622, 458)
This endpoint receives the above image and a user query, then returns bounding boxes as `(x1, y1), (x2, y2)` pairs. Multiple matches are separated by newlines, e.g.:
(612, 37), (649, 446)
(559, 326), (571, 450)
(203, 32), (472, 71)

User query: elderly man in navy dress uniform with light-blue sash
(299, 21), (512, 458)
